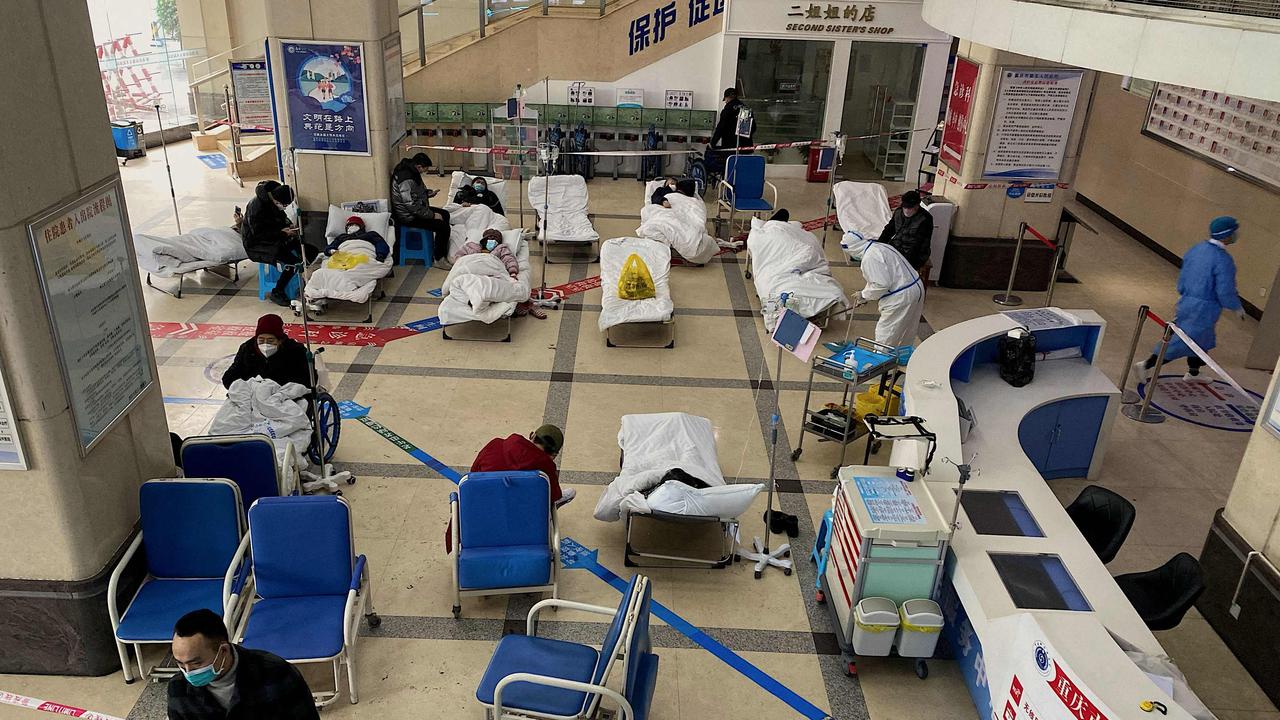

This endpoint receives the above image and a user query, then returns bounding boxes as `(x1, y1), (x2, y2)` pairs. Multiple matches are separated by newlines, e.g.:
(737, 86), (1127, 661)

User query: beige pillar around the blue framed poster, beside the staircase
(254, 0), (402, 213)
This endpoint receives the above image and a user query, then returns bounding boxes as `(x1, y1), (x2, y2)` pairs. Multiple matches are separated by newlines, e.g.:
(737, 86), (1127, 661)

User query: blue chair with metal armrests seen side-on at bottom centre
(476, 575), (658, 720)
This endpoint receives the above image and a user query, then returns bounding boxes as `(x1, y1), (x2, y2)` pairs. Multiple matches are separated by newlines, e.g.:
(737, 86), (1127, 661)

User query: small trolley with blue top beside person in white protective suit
(791, 337), (901, 479)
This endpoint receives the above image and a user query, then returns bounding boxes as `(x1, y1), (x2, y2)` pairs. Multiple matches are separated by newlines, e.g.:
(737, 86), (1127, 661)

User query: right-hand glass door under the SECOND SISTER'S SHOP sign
(838, 41), (925, 182)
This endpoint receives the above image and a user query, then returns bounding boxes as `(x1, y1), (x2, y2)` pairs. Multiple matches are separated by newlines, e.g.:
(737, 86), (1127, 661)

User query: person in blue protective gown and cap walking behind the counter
(1137, 215), (1244, 383)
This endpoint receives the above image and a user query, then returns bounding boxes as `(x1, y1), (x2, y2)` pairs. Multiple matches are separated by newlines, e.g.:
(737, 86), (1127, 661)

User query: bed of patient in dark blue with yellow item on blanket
(303, 205), (396, 323)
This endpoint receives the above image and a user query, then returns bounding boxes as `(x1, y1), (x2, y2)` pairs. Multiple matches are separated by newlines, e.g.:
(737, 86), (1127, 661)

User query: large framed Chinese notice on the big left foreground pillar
(27, 179), (155, 455)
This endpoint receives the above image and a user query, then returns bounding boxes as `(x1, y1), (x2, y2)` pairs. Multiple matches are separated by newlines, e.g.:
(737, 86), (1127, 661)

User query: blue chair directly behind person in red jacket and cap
(449, 470), (559, 618)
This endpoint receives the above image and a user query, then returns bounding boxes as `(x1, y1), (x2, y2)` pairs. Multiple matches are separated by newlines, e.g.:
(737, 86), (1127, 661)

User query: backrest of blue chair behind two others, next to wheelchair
(180, 436), (297, 510)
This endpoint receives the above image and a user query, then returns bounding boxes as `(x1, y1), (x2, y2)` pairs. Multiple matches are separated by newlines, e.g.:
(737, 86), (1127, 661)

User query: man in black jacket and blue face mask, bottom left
(168, 610), (320, 720)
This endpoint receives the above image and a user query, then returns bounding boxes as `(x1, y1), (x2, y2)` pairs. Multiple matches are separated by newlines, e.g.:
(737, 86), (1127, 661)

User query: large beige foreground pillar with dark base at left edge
(0, 0), (174, 674)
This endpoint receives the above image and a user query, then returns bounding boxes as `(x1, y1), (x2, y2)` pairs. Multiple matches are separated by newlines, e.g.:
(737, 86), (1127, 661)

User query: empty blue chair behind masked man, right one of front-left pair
(232, 496), (381, 706)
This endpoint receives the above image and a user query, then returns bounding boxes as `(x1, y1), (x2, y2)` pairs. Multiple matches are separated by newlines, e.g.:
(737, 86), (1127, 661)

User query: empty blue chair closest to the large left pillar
(106, 478), (247, 683)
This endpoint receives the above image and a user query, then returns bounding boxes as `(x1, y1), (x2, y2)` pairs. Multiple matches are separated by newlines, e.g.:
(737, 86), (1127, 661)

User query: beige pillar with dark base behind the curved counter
(934, 40), (1093, 290)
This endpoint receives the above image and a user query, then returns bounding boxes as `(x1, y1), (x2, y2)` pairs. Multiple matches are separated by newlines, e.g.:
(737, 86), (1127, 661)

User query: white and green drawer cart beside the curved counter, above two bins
(819, 465), (951, 679)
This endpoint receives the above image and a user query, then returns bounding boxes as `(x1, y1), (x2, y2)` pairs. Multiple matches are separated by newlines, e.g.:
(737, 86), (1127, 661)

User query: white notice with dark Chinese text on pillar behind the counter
(982, 68), (1084, 179)
